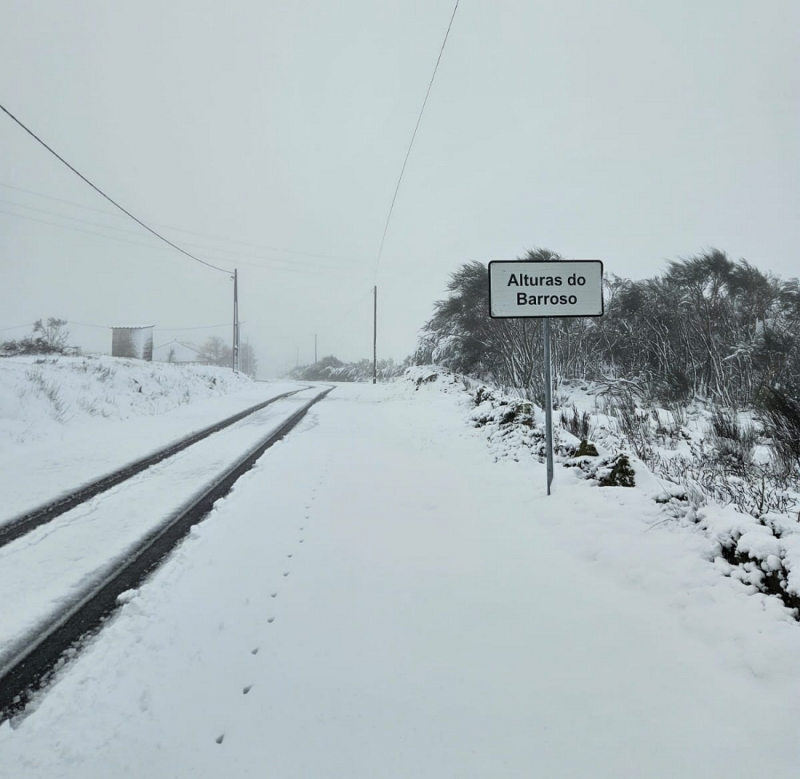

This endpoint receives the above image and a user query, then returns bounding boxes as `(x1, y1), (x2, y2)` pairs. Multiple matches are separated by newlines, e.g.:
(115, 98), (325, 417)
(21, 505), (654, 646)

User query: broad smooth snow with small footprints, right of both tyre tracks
(0, 380), (800, 779)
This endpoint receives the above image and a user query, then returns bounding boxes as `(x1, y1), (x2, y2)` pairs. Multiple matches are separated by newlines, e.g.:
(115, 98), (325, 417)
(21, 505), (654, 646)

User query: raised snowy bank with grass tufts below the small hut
(0, 356), (251, 447)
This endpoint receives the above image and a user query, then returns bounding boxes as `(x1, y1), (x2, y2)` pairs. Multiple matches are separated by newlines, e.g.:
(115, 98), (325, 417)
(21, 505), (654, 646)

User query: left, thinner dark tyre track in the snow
(0, 387), (310, 547)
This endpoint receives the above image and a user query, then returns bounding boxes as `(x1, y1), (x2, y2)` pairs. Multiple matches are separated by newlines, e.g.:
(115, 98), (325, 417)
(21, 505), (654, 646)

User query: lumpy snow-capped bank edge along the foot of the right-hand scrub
(406, 367), (800, 620)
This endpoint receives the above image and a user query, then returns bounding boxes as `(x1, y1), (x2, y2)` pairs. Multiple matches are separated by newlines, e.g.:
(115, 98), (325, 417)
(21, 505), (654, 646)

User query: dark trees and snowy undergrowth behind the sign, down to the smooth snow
(415, 249), (800, 616)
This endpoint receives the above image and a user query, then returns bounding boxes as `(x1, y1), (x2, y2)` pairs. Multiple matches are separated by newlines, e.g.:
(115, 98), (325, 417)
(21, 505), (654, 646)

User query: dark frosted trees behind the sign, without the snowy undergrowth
(415, 249), (800, 408)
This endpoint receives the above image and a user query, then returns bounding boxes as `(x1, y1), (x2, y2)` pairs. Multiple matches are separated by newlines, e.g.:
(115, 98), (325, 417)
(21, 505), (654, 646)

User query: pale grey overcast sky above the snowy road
(0, 0), (800, 376)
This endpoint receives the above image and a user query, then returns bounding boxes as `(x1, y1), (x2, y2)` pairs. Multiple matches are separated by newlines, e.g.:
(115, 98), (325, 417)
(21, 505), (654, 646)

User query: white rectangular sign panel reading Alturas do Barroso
(489, 260), (603, 319)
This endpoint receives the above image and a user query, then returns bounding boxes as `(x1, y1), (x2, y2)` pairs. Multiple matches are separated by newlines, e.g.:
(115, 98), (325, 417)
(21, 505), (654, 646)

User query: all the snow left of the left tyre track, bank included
(0, 357), (300, 522)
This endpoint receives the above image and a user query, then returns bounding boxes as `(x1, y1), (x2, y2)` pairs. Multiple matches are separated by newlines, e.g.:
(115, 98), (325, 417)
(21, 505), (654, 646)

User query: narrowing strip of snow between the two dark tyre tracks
(0, 389), (319, 673)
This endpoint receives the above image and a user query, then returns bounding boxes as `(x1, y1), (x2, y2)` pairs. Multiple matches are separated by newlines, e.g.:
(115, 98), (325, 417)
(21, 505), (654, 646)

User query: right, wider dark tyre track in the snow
(0, 387), (334, 722)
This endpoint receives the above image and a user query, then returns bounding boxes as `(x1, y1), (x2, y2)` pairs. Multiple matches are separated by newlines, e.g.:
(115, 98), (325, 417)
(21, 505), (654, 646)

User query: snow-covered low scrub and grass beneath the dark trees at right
(406, 367), (800, 619)
